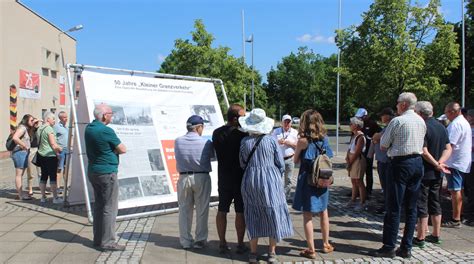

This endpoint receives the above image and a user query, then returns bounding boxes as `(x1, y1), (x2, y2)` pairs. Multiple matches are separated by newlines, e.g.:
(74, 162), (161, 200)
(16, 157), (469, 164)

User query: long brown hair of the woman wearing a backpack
(298, 109), (327, 140)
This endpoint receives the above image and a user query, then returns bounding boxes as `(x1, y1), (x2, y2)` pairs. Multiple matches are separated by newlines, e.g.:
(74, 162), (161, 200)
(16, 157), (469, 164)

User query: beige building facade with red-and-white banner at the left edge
(0, 0), (76, 155)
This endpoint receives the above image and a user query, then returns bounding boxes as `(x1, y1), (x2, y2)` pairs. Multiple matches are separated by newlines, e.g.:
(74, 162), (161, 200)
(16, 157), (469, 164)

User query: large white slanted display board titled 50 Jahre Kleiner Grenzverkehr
(68, 66), (228, 214)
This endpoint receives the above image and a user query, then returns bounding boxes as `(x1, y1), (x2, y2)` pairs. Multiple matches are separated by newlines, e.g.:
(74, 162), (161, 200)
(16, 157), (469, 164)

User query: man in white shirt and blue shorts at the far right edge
(442, 102), (472, 228)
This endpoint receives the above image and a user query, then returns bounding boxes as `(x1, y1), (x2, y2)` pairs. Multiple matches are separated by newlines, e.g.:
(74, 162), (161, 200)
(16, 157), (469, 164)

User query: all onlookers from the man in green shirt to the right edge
(79, 93), (474, 263)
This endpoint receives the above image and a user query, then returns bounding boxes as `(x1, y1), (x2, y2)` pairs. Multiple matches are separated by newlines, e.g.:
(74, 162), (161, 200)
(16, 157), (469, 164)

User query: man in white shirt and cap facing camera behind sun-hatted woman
(272, 115), (298, 202)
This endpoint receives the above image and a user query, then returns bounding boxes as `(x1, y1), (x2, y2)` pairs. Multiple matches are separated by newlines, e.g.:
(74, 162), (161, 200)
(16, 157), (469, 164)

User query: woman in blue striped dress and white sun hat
(239, 108), (293, 263)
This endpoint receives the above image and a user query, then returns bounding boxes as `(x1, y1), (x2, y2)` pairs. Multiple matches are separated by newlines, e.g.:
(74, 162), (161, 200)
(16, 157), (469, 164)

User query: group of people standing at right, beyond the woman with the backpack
(346, 92), (474, 258)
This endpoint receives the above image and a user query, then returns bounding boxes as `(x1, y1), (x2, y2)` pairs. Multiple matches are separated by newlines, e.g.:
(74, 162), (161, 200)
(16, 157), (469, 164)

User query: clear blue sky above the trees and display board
(20, 0), (462, 80)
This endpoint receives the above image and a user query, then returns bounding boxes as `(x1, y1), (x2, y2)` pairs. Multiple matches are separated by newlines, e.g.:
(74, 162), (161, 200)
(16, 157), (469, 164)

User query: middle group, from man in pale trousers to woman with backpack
(174, 104), (334, 263)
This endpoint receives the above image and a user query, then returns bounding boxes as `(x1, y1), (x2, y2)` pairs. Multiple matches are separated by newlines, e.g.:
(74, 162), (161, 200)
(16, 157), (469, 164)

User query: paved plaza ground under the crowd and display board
(0, 139), (474, 263)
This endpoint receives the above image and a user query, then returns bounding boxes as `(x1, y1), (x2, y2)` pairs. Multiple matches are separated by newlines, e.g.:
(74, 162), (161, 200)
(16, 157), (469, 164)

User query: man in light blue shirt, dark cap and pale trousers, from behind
(174, 115), (214, 249)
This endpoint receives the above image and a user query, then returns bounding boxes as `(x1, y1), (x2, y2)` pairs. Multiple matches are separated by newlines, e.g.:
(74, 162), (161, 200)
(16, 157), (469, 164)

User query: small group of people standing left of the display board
(11, 111), (69, 204)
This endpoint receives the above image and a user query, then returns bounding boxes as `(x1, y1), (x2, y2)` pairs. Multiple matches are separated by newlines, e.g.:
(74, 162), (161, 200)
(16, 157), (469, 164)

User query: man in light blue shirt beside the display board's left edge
(53, 111), (69, 193)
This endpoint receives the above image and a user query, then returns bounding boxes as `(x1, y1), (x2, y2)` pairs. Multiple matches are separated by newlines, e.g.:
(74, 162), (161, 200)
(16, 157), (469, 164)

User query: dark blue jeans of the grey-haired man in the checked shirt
(383, 155), (424, 250)
